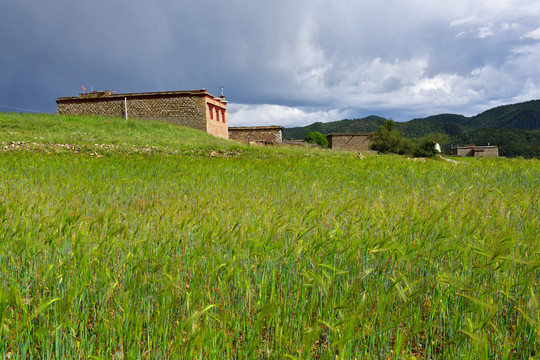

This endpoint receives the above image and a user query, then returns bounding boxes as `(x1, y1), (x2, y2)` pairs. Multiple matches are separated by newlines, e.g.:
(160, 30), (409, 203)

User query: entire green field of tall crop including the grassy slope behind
(0, 113), (540, 359)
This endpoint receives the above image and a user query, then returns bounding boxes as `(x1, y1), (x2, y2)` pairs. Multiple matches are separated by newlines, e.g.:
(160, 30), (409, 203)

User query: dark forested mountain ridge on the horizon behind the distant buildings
(283, 100), (540, 158)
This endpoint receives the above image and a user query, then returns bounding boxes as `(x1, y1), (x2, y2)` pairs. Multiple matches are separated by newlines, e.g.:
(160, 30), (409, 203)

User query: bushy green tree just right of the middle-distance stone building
(371, 119), (413, 154)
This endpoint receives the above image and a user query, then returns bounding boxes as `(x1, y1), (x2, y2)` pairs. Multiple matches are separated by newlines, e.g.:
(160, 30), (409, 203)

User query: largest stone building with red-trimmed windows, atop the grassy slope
(56, 89), (229, 138)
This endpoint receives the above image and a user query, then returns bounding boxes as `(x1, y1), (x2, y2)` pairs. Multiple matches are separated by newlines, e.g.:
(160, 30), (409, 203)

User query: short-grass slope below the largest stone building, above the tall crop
(0, 113), (343, 157)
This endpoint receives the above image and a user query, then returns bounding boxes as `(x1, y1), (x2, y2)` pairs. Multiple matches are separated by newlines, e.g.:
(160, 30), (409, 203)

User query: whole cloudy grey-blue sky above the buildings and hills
(0, 0), (540, 127)
